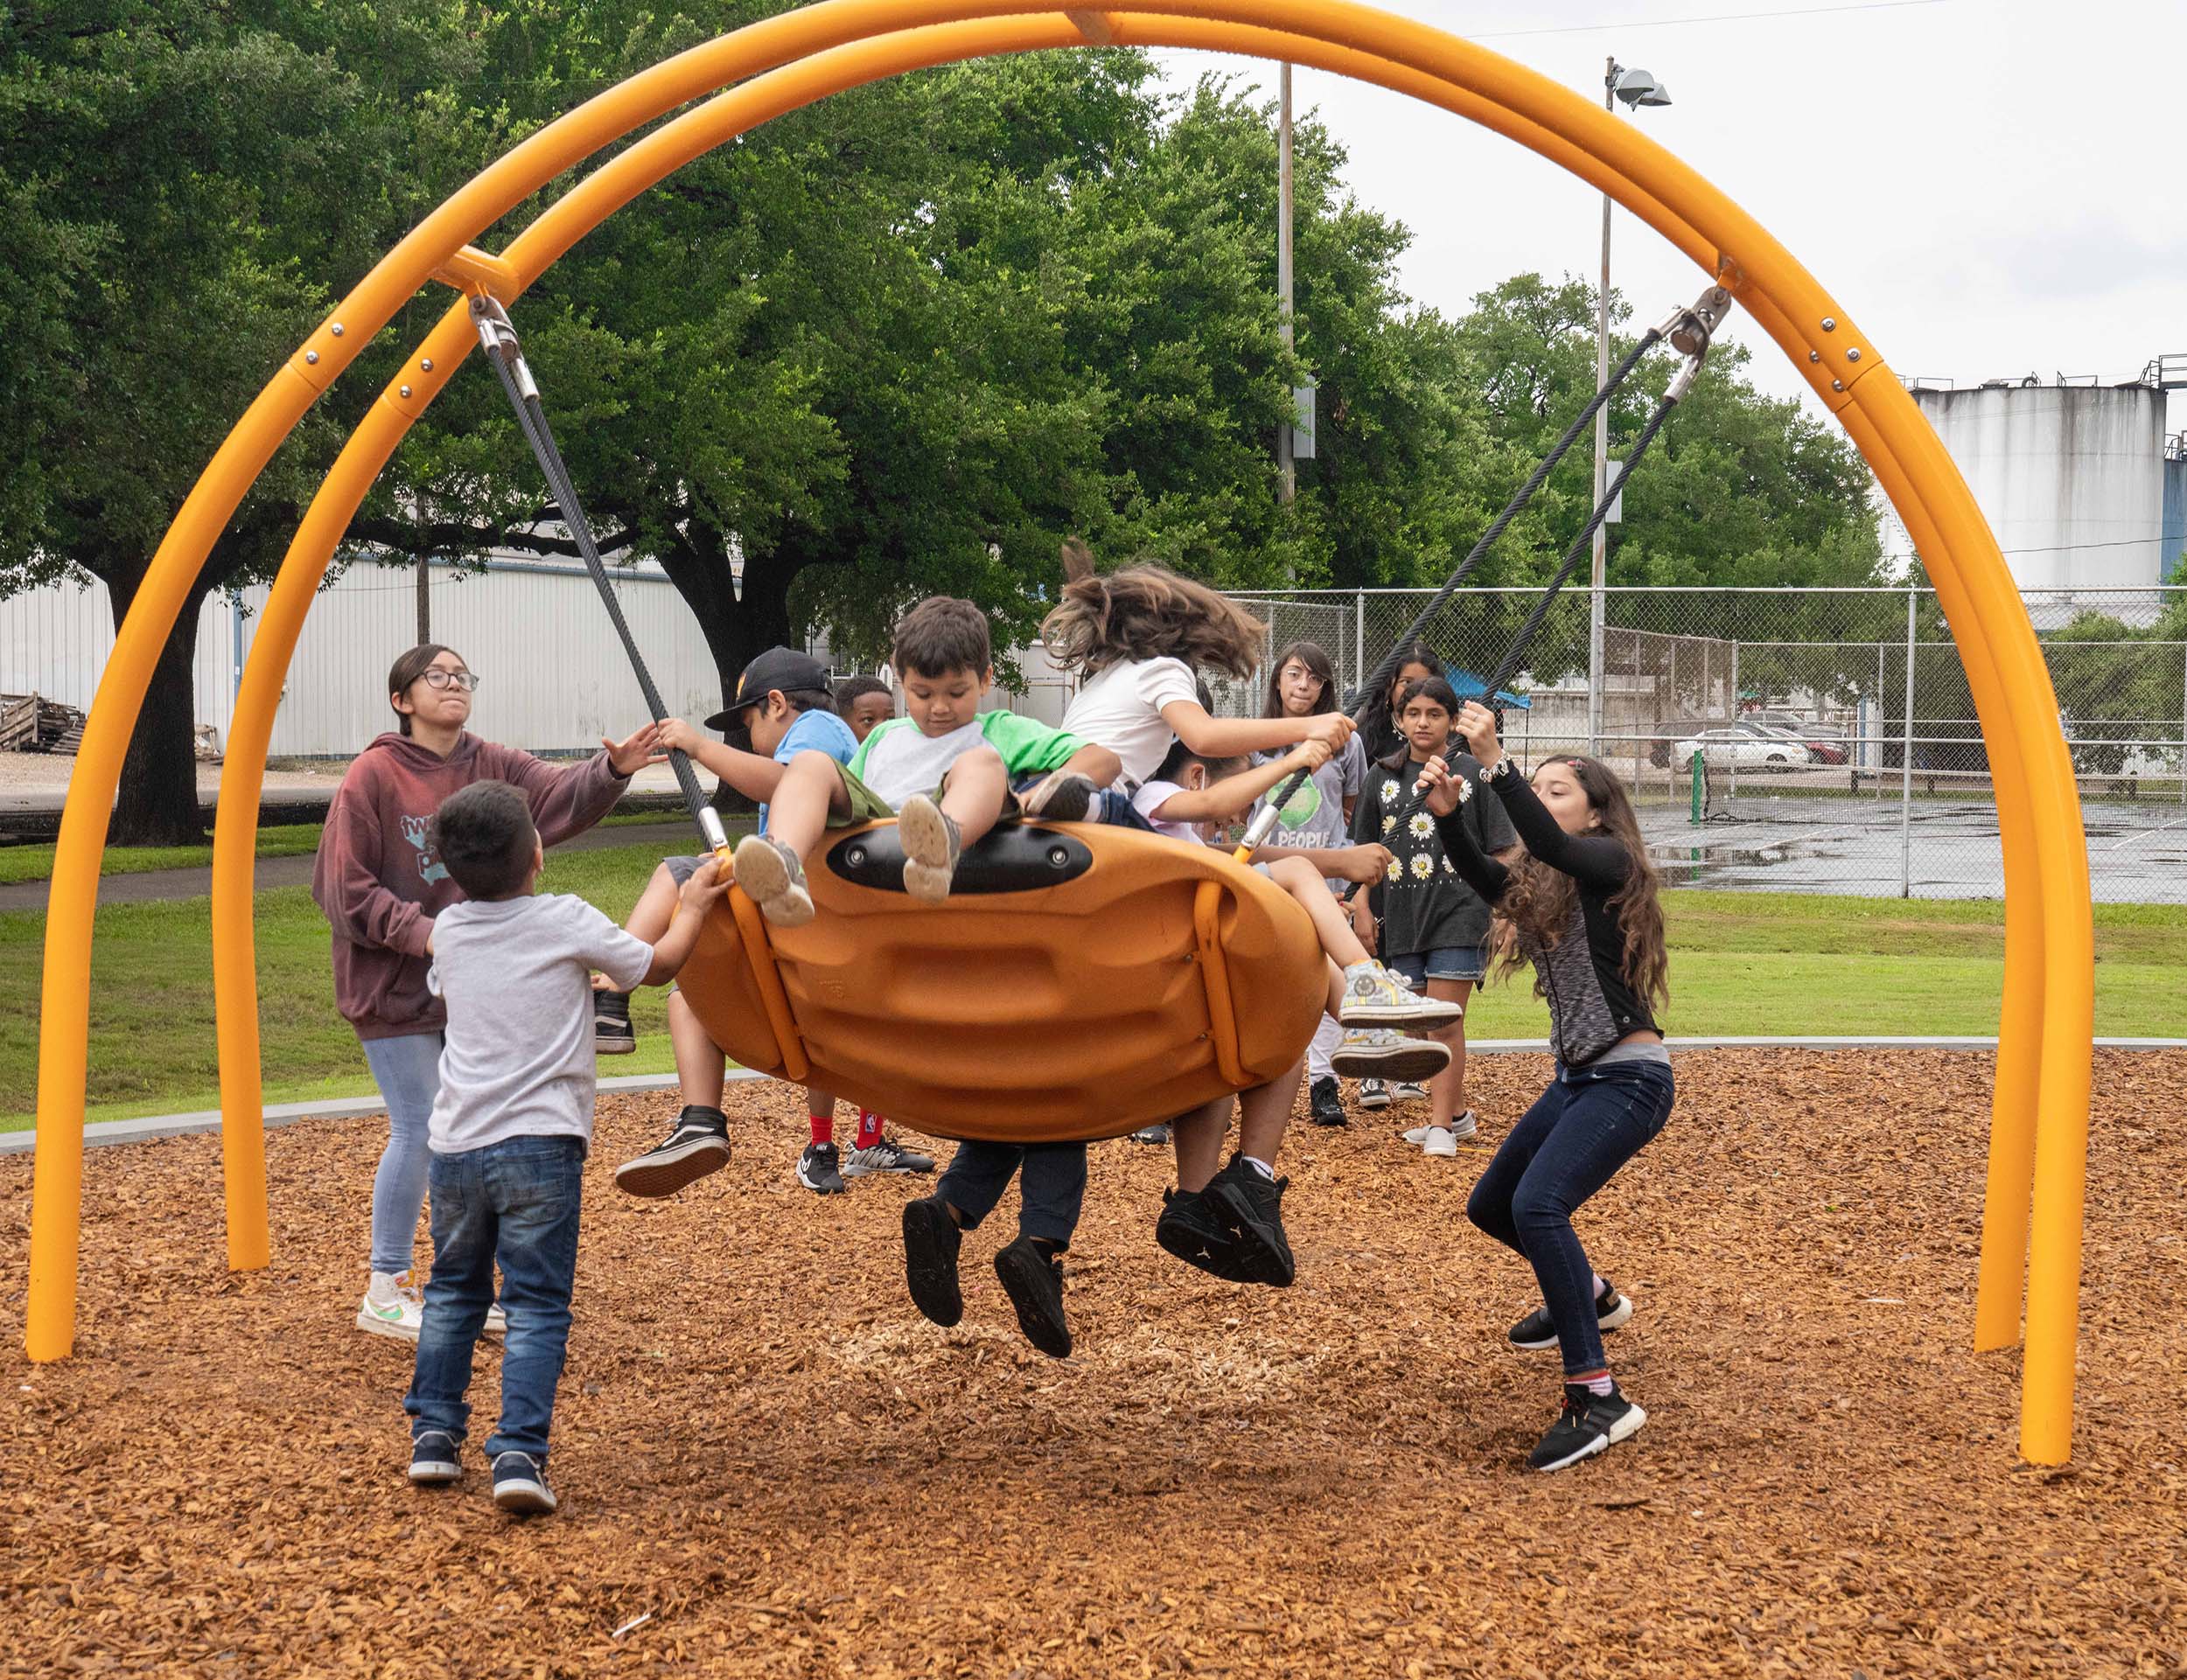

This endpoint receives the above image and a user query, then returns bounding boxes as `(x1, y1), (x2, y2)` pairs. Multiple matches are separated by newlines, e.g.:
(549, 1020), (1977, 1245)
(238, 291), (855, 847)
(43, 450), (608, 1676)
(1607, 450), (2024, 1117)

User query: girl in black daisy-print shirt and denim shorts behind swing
(1352, 676), (1518, 1157)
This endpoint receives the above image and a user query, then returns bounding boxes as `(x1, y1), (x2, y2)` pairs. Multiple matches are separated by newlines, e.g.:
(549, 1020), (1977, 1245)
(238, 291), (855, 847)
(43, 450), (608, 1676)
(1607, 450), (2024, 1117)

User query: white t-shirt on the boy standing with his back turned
(427, 893), (654, 1155)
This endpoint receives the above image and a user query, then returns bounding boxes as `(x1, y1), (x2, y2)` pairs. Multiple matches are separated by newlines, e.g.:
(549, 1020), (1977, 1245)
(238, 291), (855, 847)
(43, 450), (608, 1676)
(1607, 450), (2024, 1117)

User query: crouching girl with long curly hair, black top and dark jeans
(1417, 700), (1678, 1470)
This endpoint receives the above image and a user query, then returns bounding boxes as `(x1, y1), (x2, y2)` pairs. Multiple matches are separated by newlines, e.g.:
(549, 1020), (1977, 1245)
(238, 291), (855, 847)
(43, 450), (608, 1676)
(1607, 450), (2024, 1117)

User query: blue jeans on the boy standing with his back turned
(402, 1138), (584, 1459)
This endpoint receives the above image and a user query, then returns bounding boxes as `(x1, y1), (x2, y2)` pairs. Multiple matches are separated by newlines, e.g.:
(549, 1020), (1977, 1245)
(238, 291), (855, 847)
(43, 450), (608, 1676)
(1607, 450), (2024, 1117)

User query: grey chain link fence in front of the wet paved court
(1216, 589), (2187, 903)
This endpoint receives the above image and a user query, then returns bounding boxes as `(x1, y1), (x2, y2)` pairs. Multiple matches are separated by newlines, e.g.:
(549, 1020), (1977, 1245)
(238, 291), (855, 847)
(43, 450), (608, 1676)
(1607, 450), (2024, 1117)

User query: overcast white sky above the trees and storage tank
(1159, 0), (2187, 431)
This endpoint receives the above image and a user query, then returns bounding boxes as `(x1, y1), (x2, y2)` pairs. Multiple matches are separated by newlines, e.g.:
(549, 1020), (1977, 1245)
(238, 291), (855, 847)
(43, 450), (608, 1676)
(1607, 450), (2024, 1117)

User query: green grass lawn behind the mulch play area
(0, 845), (2187, 1129)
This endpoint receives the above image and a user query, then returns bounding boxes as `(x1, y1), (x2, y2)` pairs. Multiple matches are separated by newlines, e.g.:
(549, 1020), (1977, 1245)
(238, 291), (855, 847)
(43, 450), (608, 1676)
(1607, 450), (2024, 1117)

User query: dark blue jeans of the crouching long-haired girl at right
(1465, 1061), (1678, 1376)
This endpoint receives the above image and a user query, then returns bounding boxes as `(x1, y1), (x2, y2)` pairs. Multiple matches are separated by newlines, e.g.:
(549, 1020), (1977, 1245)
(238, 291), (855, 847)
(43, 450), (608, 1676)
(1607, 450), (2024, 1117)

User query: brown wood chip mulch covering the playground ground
(0, 1052), (2187, 1680)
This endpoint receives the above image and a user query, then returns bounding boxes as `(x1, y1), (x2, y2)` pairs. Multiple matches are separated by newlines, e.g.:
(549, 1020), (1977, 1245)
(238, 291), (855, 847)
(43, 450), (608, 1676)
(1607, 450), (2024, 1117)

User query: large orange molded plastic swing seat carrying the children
(678, 822), (1325, 1144)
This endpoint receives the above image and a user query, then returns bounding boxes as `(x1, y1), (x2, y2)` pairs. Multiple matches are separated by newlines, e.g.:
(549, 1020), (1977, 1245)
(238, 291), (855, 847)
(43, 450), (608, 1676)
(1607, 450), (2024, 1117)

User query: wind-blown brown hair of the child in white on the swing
(1041, 538), (1268, 678)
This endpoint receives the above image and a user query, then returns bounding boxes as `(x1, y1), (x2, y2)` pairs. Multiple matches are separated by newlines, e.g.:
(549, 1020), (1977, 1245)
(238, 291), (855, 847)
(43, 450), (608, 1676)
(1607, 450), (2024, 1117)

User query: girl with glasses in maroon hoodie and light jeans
(311, 643), (659, 1341)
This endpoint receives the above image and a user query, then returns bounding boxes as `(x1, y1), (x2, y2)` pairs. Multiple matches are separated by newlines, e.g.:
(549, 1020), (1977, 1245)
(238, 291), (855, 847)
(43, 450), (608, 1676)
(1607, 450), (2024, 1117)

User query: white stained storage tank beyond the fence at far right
(1914, 383), (2165, 617)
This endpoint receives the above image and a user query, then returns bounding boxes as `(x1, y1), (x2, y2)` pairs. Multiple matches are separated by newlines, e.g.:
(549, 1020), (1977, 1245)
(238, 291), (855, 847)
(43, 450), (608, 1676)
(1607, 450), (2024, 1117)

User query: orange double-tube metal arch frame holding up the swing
(24, 0), (2093, 1463)
